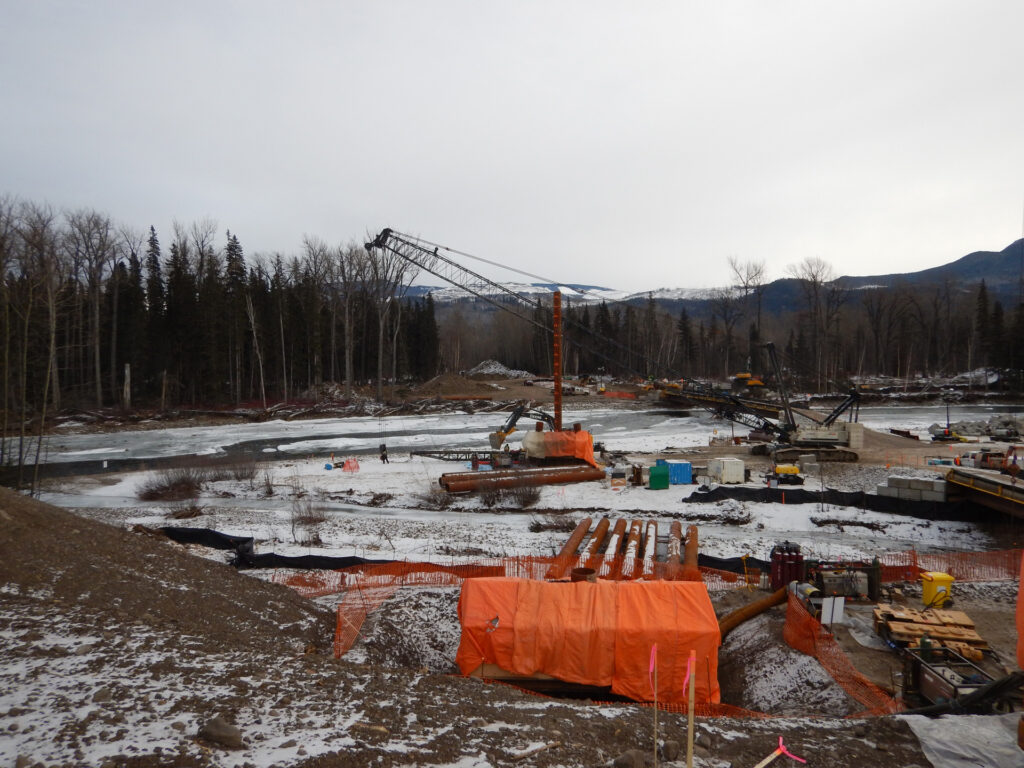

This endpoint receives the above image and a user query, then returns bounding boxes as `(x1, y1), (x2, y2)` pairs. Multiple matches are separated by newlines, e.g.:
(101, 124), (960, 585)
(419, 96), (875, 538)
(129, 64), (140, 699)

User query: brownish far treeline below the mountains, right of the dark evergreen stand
(446, 258), (1024, 392)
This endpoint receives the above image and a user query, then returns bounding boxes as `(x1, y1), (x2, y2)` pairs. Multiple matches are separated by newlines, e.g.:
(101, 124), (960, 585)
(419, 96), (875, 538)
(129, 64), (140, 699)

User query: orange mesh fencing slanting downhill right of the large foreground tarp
(782, 594), (900, 715)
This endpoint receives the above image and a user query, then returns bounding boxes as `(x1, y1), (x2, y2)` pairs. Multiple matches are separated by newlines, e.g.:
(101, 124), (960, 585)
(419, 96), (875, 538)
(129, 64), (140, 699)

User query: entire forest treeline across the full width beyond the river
(0, 198), (1024, 456)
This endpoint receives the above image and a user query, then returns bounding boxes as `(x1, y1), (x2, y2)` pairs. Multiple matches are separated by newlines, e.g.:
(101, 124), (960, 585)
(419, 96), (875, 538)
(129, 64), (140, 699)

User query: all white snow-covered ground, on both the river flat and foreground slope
(9, 407), (1024, 766)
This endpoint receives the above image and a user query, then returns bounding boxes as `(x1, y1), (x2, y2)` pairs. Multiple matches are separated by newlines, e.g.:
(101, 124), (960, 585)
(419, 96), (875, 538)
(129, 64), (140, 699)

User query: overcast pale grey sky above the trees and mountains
(0, 0), (1024, 290)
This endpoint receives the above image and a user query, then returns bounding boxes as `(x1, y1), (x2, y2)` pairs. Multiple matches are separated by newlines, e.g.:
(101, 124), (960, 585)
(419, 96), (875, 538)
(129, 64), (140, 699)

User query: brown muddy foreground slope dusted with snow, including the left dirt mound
(0, 489), (942, 768)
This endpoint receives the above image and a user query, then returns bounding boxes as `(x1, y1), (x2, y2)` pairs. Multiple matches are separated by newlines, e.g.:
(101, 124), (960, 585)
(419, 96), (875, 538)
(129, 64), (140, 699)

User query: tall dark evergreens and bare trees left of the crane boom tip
(0, 198), (439, 473)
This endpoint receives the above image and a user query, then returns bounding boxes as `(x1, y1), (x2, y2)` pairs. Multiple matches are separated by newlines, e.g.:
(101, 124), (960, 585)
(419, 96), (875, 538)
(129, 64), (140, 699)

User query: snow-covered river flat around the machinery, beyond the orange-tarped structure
(42, 408), (989, 560)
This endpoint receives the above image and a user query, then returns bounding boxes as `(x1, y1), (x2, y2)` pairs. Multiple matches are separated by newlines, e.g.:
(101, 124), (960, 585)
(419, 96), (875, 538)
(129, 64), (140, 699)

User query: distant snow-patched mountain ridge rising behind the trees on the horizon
(407, 238), (1024, 313)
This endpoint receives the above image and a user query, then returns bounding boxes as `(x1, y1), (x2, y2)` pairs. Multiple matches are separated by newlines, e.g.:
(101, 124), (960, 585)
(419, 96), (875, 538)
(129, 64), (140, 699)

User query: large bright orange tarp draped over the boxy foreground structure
(456, 578), (720, 703)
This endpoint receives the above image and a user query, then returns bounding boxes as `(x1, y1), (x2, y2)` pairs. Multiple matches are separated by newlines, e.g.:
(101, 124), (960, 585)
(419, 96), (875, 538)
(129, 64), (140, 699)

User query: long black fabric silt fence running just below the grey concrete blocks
(683, 485), (972, 520)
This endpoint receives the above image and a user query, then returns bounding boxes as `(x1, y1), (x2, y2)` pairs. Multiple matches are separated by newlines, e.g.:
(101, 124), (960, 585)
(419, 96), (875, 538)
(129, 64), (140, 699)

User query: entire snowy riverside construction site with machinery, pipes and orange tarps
(0, 229), (1024, 768)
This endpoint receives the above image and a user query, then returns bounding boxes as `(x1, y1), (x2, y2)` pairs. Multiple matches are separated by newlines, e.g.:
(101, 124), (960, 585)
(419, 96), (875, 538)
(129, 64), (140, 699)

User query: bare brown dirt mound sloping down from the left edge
(0, 487), (333, 652)
